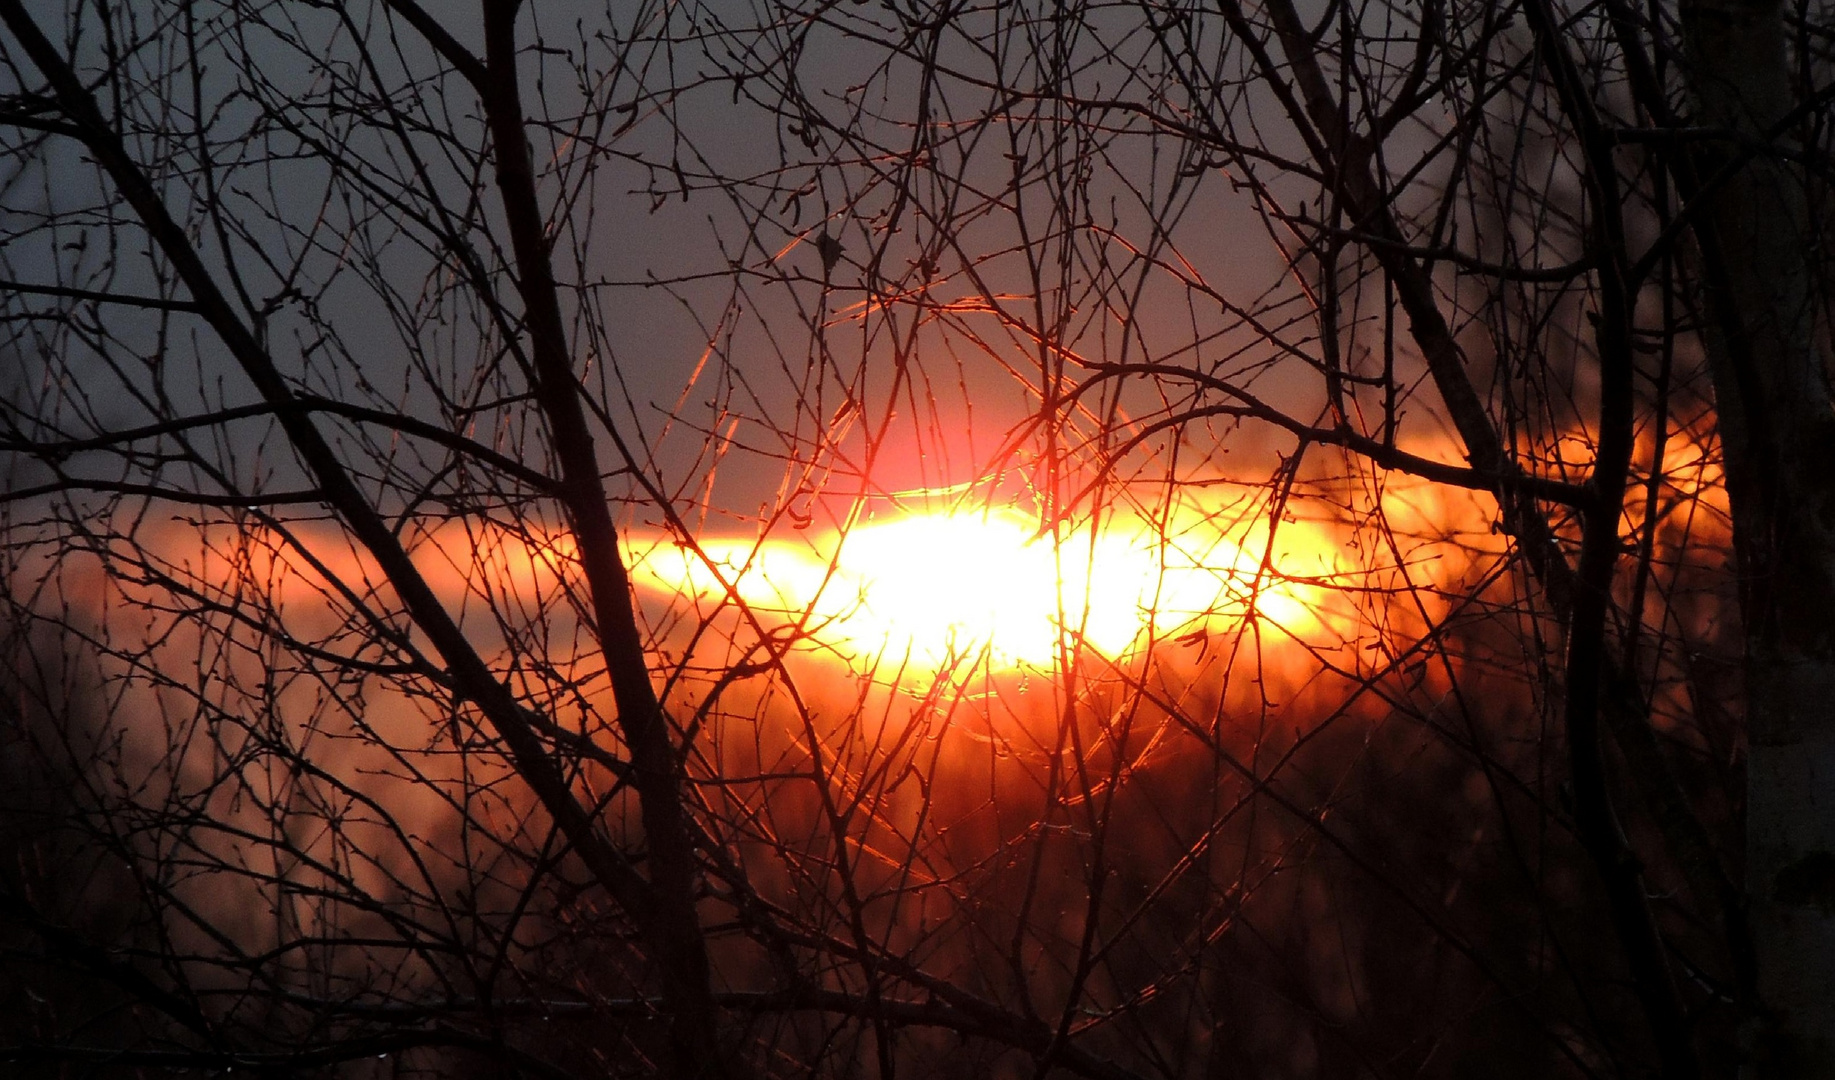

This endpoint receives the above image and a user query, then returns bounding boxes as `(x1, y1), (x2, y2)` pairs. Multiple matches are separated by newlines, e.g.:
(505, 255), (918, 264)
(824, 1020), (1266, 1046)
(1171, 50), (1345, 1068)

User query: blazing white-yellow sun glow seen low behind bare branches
(637, 512), (1335, 669)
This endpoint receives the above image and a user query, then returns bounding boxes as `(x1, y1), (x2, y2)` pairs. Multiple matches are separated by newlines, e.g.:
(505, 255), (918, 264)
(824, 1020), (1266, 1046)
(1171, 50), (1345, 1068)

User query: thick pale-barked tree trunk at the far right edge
(1683, 0), (1835, 1080)
